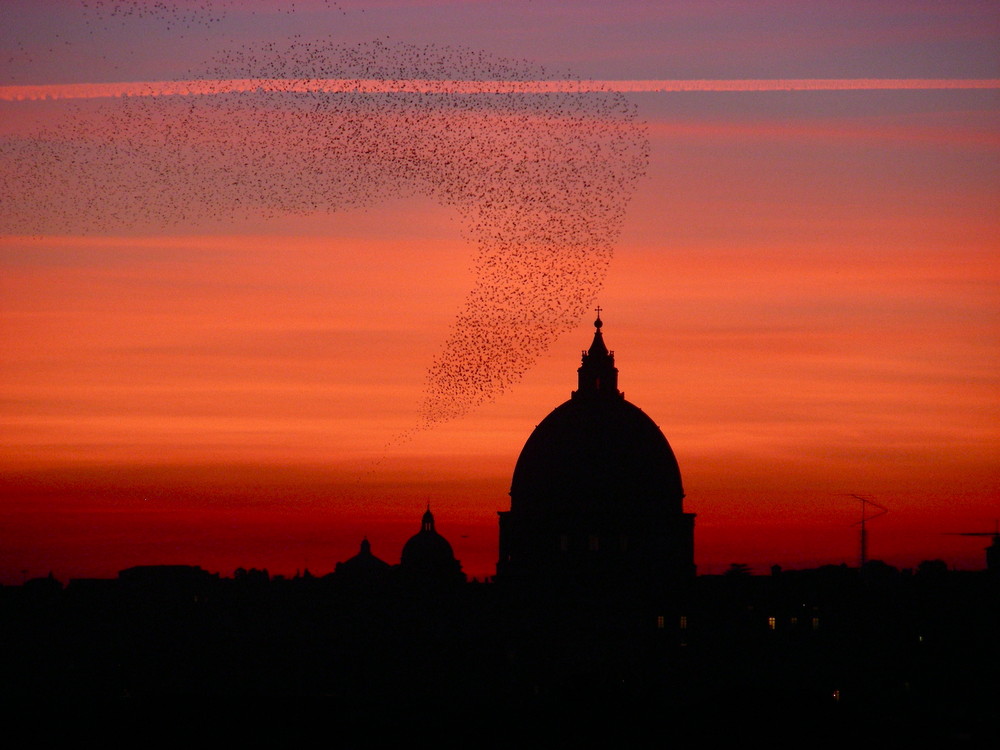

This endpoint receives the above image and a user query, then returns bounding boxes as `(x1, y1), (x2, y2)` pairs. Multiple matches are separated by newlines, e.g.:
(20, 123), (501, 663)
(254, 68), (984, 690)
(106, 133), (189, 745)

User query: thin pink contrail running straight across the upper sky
(0, 78), (1000, 101)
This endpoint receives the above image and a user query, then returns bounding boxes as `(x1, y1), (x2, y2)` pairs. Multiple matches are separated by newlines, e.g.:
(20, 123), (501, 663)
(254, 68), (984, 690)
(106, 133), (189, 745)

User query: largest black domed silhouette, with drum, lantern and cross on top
(496, 308), (695, 595)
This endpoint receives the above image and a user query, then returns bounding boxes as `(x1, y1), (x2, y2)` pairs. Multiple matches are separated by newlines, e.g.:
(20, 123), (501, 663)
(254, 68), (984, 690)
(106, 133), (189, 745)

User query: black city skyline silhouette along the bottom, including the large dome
(0, 324), (1000, 747)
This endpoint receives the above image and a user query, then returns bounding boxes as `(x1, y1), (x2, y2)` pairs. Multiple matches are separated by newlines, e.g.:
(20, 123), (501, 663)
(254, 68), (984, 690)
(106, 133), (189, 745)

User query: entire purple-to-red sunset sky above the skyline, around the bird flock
(0, 0), (1000, 583)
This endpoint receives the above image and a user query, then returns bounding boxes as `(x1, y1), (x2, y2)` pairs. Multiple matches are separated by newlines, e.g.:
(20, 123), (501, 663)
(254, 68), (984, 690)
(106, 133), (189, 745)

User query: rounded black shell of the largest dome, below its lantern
(510, 398), (684, 513)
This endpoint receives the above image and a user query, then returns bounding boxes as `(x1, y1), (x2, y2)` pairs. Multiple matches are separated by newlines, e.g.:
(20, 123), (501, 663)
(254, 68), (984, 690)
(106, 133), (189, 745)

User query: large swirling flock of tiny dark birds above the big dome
(0, 0), (649, 430)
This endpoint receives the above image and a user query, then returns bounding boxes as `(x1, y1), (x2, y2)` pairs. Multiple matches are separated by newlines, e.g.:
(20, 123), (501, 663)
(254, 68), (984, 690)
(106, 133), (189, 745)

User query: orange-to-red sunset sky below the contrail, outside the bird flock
(0, 1), (1000, 583)
